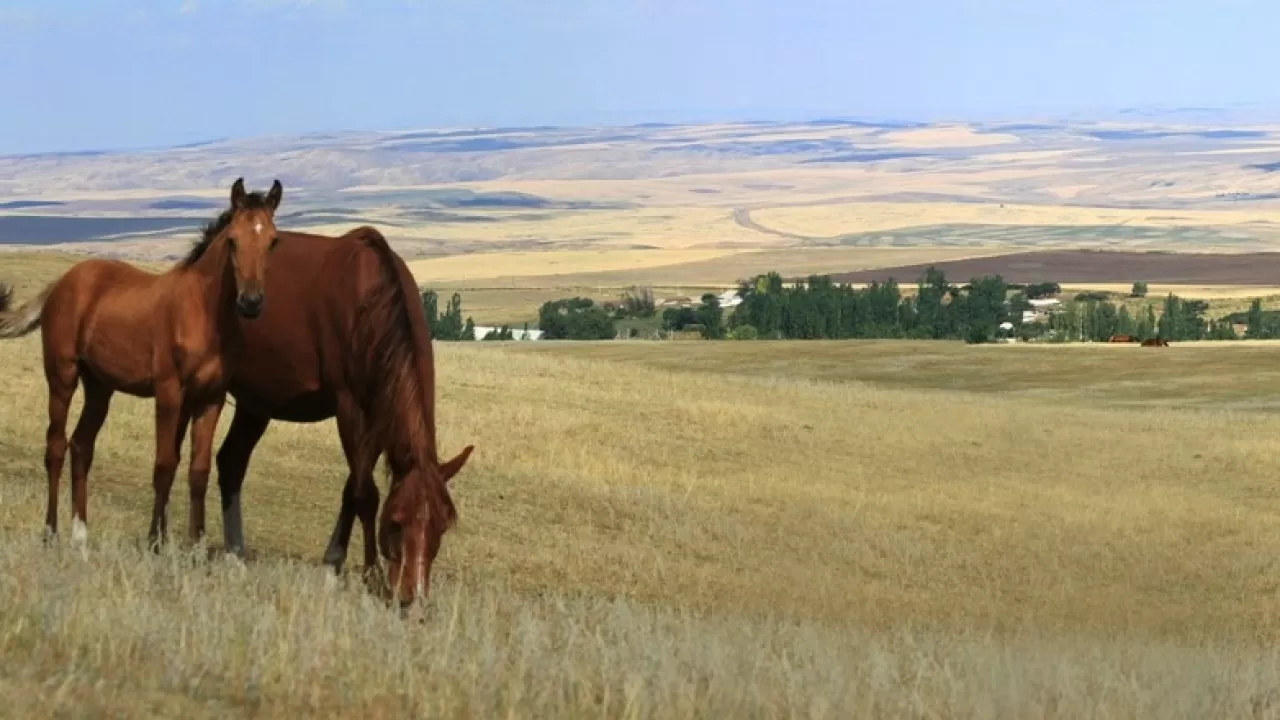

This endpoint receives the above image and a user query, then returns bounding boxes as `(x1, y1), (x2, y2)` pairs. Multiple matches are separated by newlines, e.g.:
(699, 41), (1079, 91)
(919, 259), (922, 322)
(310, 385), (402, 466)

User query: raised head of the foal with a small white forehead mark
(223, 178), (284, 319)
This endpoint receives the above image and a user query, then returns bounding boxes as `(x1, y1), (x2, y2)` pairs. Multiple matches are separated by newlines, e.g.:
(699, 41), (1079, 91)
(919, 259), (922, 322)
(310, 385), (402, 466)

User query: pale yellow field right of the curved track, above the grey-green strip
(751, 202), (1275, 237)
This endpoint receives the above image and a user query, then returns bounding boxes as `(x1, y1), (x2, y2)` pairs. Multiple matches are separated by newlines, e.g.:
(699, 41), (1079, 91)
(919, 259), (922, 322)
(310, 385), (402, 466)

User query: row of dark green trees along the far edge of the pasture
(422, 266), (1259, 343)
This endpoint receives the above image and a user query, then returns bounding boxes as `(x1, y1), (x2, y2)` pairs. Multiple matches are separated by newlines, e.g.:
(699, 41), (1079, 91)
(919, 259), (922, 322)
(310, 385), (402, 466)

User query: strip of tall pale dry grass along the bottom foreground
(0, 517), (1280, 719)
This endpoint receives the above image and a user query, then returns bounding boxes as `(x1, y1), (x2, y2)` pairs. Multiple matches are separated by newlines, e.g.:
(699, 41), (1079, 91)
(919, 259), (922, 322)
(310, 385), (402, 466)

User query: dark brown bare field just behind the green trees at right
(832, 250), (1280, 286)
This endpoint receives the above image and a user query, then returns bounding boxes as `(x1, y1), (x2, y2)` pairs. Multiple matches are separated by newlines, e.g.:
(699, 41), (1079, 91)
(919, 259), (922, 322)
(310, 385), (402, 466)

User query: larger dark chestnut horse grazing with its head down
(207, 227), (472, 605)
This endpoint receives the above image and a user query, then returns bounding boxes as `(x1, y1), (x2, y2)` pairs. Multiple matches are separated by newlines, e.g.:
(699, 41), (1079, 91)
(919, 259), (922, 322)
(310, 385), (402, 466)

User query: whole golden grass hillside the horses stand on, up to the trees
(0, 324), (1280, 717)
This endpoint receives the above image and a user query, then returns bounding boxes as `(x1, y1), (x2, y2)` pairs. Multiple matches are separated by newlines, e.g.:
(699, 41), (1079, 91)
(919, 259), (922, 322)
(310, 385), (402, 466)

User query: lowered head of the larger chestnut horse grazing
(378, 445), (475, 607)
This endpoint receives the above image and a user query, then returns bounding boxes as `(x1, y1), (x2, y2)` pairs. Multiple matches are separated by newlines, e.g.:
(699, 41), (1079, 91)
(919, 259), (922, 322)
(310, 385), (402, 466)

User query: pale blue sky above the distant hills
(0, 0), (1280, 152)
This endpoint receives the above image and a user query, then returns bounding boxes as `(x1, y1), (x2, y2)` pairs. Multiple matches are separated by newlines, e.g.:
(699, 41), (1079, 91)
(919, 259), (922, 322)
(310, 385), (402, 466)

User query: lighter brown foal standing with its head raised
(0, 178), (283, 546)
